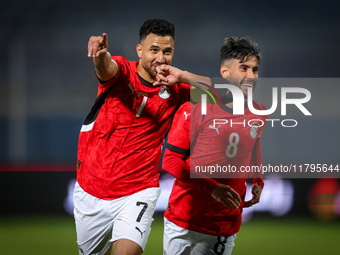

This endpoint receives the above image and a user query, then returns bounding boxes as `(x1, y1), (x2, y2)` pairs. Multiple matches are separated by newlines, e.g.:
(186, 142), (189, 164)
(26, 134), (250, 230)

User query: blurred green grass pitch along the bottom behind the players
(0, 216), (340, 255)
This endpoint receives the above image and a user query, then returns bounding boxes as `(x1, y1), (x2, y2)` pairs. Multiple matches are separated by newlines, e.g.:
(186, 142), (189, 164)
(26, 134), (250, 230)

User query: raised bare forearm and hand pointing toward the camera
(87, 33), (118, 81)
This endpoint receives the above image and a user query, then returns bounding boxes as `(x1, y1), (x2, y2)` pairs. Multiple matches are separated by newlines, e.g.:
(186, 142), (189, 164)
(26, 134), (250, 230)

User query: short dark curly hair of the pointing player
(139, 19), (175, 42)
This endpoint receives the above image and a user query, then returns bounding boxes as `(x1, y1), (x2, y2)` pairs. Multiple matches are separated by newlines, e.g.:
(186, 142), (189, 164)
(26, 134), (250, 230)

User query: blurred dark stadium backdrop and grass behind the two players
(0, 0), (340, 255)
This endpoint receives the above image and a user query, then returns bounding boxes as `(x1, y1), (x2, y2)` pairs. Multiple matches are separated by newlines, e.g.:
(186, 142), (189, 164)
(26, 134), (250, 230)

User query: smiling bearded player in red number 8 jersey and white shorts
(158, 38), (267, 255)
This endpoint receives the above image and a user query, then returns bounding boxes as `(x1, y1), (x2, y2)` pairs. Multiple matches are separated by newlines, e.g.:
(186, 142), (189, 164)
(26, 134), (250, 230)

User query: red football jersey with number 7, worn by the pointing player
(77, 56), (190, 199)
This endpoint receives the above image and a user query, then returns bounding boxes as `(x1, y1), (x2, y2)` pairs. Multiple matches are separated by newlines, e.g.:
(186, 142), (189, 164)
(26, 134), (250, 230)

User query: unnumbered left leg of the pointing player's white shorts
(73, 183), (113, 255)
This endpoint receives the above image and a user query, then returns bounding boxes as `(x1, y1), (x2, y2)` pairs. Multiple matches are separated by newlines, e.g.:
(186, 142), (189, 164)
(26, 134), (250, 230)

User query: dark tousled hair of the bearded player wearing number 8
(220, 37), (262, 65)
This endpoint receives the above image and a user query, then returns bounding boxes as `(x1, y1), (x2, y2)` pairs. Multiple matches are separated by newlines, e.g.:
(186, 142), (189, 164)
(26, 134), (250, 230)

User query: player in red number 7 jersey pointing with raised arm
(74, 19), (190, 255)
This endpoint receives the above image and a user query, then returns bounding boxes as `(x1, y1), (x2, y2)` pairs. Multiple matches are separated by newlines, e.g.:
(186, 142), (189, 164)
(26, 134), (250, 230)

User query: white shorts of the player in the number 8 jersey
(163, 218), (236, 255)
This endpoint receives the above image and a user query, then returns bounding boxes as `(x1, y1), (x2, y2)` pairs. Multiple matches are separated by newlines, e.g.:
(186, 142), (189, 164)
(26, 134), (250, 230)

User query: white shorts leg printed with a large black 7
(111, 188), (160, 250)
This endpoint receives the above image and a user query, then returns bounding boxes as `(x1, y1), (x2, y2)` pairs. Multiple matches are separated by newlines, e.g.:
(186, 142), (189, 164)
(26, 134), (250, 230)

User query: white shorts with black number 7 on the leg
(73, 182), (161, 255)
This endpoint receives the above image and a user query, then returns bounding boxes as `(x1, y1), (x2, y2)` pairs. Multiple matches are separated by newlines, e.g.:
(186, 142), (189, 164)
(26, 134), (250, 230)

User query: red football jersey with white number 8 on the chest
(163, 102), (267, 236)
